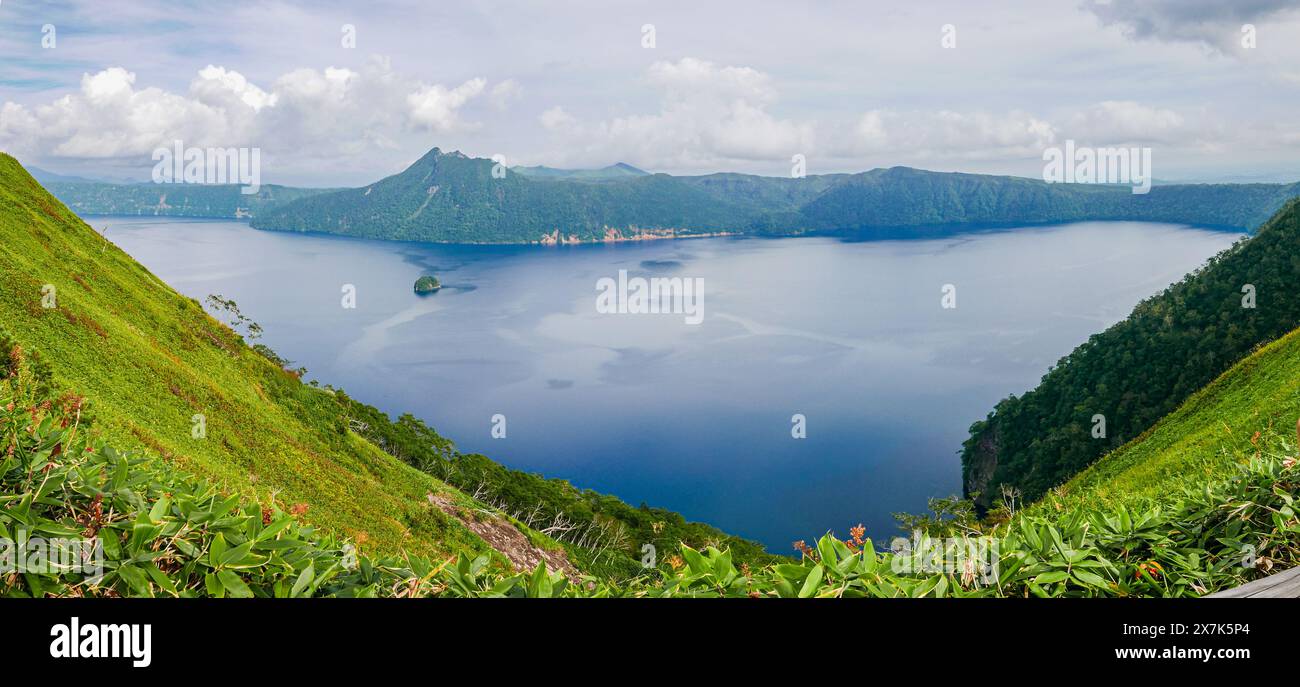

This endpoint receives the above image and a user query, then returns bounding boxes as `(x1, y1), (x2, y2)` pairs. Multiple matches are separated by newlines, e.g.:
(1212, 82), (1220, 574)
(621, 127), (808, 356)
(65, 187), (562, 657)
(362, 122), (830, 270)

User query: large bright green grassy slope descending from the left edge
(0, 155), (517, 556)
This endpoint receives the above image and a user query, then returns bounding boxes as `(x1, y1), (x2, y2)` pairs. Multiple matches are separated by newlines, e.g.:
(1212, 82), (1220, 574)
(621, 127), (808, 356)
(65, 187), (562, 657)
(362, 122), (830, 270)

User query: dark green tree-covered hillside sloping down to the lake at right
(962, 197), (1300, 505)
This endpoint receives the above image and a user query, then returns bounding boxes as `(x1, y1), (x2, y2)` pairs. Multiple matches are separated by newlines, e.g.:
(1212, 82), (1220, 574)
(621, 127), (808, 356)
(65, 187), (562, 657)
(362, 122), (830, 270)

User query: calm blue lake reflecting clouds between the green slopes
(91, 217), (1240, 553)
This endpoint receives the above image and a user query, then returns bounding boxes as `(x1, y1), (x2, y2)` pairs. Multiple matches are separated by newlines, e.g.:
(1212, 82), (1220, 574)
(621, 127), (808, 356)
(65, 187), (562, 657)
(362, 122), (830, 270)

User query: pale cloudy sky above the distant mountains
(0, 0), (1300, 186)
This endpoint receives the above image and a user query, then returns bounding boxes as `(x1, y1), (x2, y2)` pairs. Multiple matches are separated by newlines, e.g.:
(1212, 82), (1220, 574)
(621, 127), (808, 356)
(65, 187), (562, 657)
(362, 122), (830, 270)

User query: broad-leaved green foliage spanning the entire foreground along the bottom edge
(0, 341), (1300, 599)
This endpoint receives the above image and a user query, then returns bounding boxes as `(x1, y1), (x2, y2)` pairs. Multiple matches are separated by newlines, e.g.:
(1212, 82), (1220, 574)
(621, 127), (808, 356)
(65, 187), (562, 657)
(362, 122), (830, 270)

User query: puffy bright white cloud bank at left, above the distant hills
(0, 59), (496, 170)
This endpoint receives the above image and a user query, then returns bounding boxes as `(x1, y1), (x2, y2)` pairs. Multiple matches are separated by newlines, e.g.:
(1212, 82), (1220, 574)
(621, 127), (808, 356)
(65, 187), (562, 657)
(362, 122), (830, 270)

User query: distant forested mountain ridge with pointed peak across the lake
(252, 148), (1300, 243)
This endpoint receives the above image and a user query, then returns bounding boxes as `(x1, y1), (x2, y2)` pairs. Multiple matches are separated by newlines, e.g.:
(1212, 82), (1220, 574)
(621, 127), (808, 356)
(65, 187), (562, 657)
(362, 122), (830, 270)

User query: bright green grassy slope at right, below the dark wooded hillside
(1036, 329), (1300, 509)
